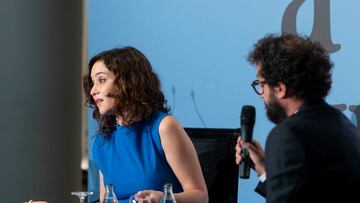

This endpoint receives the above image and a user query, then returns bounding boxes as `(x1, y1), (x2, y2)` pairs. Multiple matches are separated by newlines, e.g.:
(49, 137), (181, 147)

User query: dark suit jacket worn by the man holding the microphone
(257, 102), (360, 203)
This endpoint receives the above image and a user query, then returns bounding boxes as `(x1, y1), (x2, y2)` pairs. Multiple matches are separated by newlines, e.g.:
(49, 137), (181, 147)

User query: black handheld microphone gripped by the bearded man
(239, 105), (256, 179)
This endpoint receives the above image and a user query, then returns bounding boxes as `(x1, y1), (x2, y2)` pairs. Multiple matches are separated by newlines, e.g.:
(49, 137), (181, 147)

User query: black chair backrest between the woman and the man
(185, 128), (240, 203)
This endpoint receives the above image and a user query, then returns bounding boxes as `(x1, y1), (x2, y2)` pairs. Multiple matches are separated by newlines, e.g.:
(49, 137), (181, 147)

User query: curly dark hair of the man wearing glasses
(248, 34), (333, 101)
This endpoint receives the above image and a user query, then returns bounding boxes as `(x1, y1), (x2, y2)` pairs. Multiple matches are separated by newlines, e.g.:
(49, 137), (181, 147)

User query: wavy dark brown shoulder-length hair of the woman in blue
(83, 47), (169, 134)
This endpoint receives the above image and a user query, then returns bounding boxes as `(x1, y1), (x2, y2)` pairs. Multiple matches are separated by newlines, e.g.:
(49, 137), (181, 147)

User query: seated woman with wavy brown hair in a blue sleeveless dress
(84, 47), (208, 203)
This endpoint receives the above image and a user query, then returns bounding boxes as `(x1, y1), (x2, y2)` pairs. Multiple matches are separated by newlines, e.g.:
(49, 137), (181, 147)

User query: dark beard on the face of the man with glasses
(265, 92), (286, 124)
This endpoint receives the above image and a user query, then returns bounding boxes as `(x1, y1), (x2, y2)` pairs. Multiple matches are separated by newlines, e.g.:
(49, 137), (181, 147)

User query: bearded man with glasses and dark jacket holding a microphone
(235, 34), (360, 203)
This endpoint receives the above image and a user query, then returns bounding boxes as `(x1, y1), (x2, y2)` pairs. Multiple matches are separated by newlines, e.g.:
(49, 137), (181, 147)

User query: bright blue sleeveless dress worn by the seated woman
(93, 111), (182, 202)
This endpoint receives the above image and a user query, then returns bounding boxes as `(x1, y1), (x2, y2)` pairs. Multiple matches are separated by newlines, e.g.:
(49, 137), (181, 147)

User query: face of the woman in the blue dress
(90, 61), (115, 115)
